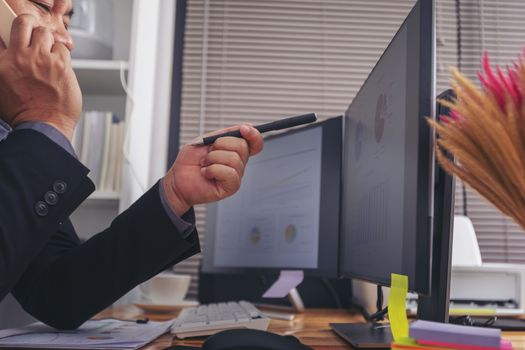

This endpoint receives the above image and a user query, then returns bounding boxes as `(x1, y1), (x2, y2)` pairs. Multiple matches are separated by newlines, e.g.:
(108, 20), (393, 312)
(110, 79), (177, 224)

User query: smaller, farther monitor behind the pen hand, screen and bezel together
(202, 117), (342, 277)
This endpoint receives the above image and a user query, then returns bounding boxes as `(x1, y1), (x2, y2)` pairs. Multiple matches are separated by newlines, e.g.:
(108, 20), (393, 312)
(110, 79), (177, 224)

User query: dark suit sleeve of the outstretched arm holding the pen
(14, 183), (200, 329)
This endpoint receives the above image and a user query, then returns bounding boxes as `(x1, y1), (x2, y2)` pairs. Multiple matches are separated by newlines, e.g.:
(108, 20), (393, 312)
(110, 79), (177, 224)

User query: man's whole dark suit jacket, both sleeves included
(0, 130), (200, 329)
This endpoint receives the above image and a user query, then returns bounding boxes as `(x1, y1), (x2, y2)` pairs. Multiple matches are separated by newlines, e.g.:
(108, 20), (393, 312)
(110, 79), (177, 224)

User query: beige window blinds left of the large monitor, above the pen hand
(176, 0), (415, 296)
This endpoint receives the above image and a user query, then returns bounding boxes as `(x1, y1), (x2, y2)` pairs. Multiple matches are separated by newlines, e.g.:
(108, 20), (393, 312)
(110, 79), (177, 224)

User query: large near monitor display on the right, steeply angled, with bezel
(341, 3), (434, 294)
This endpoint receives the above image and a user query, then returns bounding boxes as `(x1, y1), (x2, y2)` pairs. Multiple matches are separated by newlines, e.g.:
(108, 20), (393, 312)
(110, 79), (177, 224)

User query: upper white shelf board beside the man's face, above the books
(72, 59), (129, 95)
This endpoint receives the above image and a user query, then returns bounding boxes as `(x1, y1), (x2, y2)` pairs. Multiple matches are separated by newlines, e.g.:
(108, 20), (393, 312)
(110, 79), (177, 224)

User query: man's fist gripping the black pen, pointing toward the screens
(162, 124), (263, 216)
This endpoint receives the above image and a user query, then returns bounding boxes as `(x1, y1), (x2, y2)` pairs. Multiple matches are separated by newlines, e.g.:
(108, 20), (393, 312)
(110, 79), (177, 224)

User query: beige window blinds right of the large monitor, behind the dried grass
(449, 0), (525, 263)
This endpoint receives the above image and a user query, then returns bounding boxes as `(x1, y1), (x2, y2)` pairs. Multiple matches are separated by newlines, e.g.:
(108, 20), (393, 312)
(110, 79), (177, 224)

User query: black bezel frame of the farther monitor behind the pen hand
(201, 116), (343, 278)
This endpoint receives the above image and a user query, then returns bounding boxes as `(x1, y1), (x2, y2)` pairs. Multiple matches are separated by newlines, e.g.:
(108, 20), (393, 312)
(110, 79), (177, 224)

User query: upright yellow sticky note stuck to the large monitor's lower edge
(388, 273), (408, 341)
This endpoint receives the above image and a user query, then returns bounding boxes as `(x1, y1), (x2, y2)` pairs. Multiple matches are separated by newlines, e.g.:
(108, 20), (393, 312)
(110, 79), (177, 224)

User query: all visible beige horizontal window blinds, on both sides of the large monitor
(176, 0), (525, 297)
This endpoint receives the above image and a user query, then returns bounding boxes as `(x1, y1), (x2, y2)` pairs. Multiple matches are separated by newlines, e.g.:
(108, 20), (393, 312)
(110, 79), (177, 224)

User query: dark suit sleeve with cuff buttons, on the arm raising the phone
(0, 130), (94, 300)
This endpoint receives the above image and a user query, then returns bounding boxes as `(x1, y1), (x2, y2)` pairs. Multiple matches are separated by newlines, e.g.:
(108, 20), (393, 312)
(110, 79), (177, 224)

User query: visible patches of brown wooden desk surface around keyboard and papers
(99, 306), (525, 350)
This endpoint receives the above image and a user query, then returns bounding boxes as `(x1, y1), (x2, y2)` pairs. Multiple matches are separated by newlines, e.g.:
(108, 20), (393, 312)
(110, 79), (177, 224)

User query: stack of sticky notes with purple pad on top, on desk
(392, 321), (512, 350)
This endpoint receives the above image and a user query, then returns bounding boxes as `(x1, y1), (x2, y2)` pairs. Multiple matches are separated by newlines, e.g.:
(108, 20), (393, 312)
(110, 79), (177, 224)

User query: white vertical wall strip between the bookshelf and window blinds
(120, 0), (175, 211)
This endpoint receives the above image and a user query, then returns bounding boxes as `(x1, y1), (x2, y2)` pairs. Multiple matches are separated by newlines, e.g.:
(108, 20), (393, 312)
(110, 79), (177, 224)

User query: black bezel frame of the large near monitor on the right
(339, 0), (435, 296)
